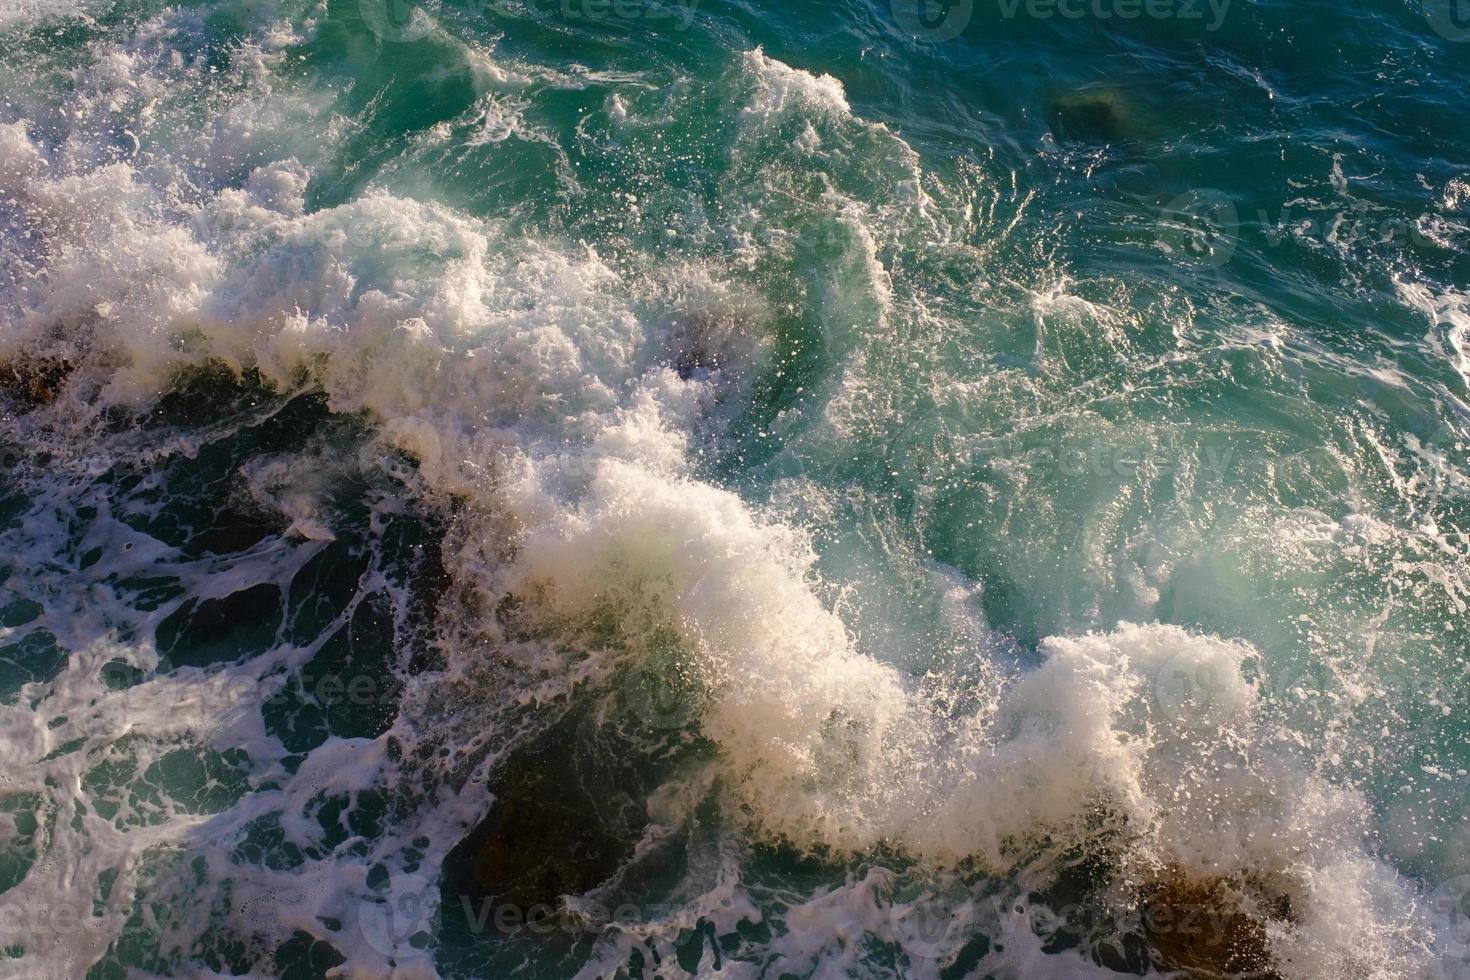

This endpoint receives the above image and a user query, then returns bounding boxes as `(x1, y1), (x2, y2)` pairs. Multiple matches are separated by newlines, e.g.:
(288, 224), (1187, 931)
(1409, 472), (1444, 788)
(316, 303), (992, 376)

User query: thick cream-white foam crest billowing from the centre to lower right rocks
(482, 387), (1424, 977)
